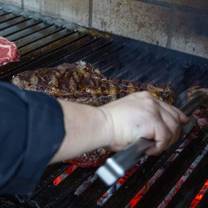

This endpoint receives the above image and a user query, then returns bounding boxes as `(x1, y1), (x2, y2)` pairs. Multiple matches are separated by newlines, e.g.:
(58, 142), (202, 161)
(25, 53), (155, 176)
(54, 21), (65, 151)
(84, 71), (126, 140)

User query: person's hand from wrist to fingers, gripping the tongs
(100, 92), (188, 155)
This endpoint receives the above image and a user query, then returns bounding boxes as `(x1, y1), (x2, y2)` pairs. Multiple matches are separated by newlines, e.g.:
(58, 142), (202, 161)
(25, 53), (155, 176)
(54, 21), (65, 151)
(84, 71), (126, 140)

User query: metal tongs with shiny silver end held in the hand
(96, 92), (208, 186)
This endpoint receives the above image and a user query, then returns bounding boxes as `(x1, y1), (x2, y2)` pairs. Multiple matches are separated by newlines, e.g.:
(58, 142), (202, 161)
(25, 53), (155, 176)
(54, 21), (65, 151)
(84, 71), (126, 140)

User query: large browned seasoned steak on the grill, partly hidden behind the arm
(12, 62), (174, 167)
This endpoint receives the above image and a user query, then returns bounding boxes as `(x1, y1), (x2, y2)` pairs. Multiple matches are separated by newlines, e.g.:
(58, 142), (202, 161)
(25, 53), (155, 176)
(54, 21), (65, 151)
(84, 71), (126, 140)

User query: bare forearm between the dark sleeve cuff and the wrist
(51, 100), (112, 163)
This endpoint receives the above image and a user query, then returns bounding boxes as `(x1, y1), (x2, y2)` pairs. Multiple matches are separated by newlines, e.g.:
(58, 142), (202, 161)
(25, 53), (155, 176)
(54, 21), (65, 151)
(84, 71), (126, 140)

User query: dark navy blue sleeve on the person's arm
(0, 82), (65, 194)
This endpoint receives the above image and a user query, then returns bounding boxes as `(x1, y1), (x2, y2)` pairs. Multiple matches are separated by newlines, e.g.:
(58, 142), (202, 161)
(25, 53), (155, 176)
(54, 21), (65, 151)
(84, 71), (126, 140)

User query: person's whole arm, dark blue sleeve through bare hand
(0, 83), (187, 194)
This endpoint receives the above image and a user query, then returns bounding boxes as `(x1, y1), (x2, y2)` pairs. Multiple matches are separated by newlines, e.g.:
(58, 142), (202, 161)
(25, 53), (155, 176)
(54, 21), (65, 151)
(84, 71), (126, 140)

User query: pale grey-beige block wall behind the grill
(0, 0), (208, 58)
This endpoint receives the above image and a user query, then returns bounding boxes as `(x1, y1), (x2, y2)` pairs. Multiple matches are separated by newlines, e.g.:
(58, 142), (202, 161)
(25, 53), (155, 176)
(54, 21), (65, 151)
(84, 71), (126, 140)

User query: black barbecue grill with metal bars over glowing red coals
(0, 4), (208, 208)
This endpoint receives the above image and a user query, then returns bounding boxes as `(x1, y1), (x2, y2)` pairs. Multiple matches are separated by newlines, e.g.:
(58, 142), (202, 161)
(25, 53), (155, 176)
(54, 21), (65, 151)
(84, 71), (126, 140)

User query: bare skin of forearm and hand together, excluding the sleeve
(52, 92), (187, 162)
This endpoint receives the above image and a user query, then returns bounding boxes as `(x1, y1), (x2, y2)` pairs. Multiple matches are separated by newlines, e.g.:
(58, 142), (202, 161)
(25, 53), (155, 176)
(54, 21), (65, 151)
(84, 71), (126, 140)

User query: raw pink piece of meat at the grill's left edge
(0, 37), (19, 66)
